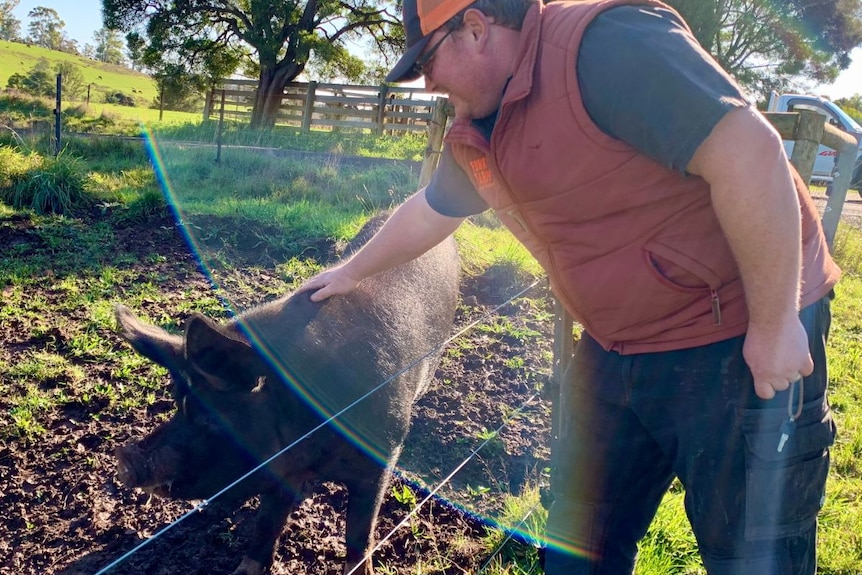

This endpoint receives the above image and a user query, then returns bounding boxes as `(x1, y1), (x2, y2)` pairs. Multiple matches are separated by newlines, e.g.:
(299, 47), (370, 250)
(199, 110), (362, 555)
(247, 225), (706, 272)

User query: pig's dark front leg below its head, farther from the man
(233, 489), (300, 575)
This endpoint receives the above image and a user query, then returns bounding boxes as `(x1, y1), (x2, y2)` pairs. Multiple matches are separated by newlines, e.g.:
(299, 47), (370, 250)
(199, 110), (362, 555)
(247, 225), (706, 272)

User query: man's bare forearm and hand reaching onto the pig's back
(301, 188), (464, 301)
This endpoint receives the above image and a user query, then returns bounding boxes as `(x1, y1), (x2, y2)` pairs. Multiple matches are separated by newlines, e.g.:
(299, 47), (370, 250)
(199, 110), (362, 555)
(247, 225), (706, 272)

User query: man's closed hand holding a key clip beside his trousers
(742, 315), (814, 399)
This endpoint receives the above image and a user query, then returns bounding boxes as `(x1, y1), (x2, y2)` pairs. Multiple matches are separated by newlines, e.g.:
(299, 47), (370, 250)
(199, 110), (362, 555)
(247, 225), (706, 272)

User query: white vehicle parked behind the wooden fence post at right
(767, 92), (862, 194)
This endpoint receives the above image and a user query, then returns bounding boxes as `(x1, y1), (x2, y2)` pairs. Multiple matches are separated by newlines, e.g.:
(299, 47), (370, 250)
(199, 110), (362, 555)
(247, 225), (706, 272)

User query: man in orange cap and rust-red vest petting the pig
(306, 0), (839, 575)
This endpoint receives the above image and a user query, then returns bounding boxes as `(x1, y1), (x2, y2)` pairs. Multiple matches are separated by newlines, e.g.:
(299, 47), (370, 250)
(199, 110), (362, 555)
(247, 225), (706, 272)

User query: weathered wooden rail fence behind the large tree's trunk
(203, 80), (447, 133)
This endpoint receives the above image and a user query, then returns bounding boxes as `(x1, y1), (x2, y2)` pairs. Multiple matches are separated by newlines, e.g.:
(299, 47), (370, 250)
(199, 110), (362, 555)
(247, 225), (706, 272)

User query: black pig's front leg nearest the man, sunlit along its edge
(344, 463), (392, 575)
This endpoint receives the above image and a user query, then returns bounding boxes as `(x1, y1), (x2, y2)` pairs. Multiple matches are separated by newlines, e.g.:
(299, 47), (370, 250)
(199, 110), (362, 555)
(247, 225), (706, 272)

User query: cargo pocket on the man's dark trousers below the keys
(742, 398), (835, 541)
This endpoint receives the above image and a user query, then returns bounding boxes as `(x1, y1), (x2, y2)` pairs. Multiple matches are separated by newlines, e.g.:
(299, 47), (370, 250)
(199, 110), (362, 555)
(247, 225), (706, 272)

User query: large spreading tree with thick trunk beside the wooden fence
(102, 0), (403, 127)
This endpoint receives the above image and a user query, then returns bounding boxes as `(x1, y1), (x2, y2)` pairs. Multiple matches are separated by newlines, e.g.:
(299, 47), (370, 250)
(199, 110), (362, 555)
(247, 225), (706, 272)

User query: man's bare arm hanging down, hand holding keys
(687, 104), (814, 399)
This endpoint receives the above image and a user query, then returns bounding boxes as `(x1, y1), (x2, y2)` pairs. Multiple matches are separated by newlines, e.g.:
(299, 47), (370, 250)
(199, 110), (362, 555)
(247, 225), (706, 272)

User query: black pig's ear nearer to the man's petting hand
(186, 314), (261, 391)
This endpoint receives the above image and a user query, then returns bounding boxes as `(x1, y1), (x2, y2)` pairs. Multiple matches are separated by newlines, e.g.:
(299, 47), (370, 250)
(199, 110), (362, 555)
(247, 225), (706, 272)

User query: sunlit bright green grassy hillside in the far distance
(0, 40), (157, 106)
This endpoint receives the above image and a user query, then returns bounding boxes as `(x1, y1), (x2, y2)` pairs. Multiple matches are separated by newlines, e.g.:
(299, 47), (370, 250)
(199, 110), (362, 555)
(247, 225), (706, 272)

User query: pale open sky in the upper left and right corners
(14, 0), (862, 99)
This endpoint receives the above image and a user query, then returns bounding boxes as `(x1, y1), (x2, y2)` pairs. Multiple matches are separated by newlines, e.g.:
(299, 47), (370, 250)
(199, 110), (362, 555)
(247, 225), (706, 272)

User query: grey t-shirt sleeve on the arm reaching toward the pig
(425, 146), (488, 218)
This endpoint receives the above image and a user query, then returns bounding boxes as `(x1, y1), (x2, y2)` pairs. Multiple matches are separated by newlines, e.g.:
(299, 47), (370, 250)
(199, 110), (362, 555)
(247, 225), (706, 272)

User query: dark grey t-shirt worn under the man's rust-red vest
(425, 6), (748, 217)
